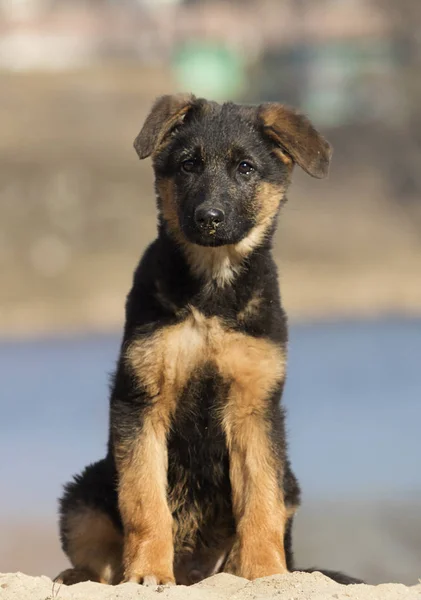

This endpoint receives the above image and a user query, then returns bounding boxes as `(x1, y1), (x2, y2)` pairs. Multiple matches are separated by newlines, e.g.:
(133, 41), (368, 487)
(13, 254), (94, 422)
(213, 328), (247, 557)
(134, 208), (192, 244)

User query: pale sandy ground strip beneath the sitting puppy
(0, 573), (421, 600)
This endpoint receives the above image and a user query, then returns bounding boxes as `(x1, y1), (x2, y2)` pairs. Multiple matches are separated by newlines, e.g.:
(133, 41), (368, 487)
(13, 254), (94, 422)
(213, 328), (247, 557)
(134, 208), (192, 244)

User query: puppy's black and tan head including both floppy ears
(134, 95), (331, 248)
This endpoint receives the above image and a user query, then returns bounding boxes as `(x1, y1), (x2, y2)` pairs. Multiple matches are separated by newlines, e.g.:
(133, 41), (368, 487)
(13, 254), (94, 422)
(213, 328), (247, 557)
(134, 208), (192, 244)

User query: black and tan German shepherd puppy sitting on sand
(58, 95), (358, 585)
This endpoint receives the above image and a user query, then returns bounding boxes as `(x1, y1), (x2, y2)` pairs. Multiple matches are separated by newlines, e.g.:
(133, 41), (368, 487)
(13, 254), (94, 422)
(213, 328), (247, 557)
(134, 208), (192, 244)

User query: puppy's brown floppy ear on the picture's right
(258, 103), (332, 179)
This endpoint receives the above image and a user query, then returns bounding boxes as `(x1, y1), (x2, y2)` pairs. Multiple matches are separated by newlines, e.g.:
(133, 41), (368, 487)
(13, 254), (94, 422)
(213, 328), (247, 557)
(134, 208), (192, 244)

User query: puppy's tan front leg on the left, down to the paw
(111, 364), (175, 585)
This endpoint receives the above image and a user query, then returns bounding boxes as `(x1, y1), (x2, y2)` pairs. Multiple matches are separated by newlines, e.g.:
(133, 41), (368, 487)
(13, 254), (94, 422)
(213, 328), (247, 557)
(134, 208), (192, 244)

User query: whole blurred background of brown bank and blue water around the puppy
(0, 0), (421, 583)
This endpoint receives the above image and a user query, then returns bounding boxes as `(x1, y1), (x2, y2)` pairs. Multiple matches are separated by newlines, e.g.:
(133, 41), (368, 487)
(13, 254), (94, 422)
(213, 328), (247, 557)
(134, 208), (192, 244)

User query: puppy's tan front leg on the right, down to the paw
(223, 339), (288, 579)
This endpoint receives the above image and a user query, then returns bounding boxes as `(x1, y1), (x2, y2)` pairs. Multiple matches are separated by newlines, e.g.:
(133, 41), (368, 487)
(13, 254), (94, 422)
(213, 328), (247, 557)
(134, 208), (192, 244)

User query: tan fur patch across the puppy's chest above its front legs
(127, 307), (285, 413)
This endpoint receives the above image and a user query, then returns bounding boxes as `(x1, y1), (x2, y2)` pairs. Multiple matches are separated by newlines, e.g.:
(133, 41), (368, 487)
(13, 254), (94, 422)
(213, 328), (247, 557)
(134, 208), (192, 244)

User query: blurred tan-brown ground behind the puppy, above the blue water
(0, 64), (421, 334)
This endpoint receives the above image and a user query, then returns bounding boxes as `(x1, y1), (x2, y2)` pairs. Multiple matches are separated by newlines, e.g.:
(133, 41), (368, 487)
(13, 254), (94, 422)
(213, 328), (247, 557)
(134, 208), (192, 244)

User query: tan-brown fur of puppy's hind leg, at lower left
(59, 507), (123, 584)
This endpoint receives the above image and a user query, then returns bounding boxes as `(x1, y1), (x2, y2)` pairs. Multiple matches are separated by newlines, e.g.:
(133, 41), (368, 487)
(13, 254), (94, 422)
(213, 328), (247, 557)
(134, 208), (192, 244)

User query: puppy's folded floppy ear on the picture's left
(134, 94), (196, 159)
